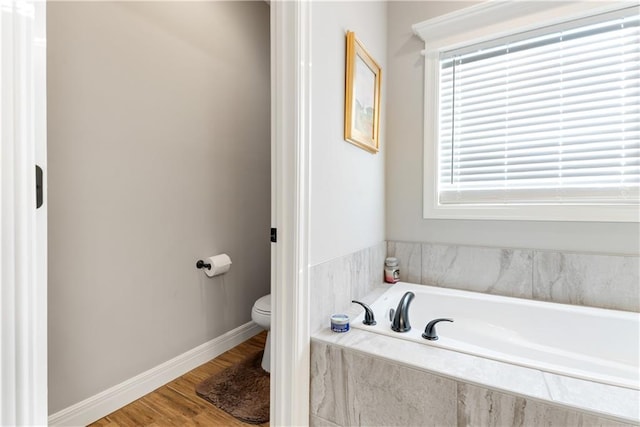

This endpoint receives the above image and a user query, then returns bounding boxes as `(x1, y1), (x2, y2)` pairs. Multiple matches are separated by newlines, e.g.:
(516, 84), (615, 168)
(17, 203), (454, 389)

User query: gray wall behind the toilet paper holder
(47, 1), (270, 413)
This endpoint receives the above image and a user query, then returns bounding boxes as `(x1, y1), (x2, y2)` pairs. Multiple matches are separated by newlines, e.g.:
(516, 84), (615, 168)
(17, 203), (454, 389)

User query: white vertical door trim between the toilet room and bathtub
(270, 0), (311, 426)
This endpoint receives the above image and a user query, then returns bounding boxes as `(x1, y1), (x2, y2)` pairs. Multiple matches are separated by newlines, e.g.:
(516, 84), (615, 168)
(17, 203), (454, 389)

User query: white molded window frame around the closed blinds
(413, 1), (640, 222)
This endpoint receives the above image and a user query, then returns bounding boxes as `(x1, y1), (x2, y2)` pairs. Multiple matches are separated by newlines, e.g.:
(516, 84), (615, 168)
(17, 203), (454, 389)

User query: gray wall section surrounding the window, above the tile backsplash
(386, 1), (640, 254)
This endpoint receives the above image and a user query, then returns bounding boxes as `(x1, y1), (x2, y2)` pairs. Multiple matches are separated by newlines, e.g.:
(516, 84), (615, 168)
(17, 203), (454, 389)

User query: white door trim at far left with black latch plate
(0, 0), (47, 425)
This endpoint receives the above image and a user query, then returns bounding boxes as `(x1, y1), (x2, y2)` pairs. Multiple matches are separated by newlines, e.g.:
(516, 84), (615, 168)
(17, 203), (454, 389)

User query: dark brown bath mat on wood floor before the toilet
(196, 351), (269, 424)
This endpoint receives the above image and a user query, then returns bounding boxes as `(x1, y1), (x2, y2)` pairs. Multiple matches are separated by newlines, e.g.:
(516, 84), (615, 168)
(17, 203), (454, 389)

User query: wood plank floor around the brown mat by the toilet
(90, 331), (269, 427)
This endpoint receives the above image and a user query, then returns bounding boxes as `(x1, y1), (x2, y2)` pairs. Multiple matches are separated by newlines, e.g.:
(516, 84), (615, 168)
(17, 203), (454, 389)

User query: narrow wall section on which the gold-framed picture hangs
(309, 1), (388, 265)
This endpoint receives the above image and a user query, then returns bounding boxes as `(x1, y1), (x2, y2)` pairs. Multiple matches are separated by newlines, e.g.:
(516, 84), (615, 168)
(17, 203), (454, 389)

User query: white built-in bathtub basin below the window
(351, 282), (640, 390)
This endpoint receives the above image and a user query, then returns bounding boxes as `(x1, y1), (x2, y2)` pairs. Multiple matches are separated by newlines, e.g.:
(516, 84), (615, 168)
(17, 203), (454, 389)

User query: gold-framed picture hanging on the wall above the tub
(344, 31), (382, 153)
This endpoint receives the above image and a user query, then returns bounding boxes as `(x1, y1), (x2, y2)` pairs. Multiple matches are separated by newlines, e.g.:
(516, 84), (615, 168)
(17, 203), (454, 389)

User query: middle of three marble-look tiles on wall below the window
(420, 243), (533, 298)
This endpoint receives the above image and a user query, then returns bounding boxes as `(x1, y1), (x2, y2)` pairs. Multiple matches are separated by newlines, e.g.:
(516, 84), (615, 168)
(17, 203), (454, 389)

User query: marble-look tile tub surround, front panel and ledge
(310, 328), (640, 427)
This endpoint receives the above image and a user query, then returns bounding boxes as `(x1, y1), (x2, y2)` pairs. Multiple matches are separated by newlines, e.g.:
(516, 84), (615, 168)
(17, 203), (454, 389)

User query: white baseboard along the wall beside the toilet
(49, 322), (262, 426)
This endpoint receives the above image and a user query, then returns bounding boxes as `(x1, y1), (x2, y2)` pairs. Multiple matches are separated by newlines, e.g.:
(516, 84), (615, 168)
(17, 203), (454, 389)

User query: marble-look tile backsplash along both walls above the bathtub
(310, 241), (640, 333)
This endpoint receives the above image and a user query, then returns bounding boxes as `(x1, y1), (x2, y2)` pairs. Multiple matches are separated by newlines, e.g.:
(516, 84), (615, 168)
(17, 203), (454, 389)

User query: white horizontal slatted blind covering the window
(438, 8), (640, 205)
